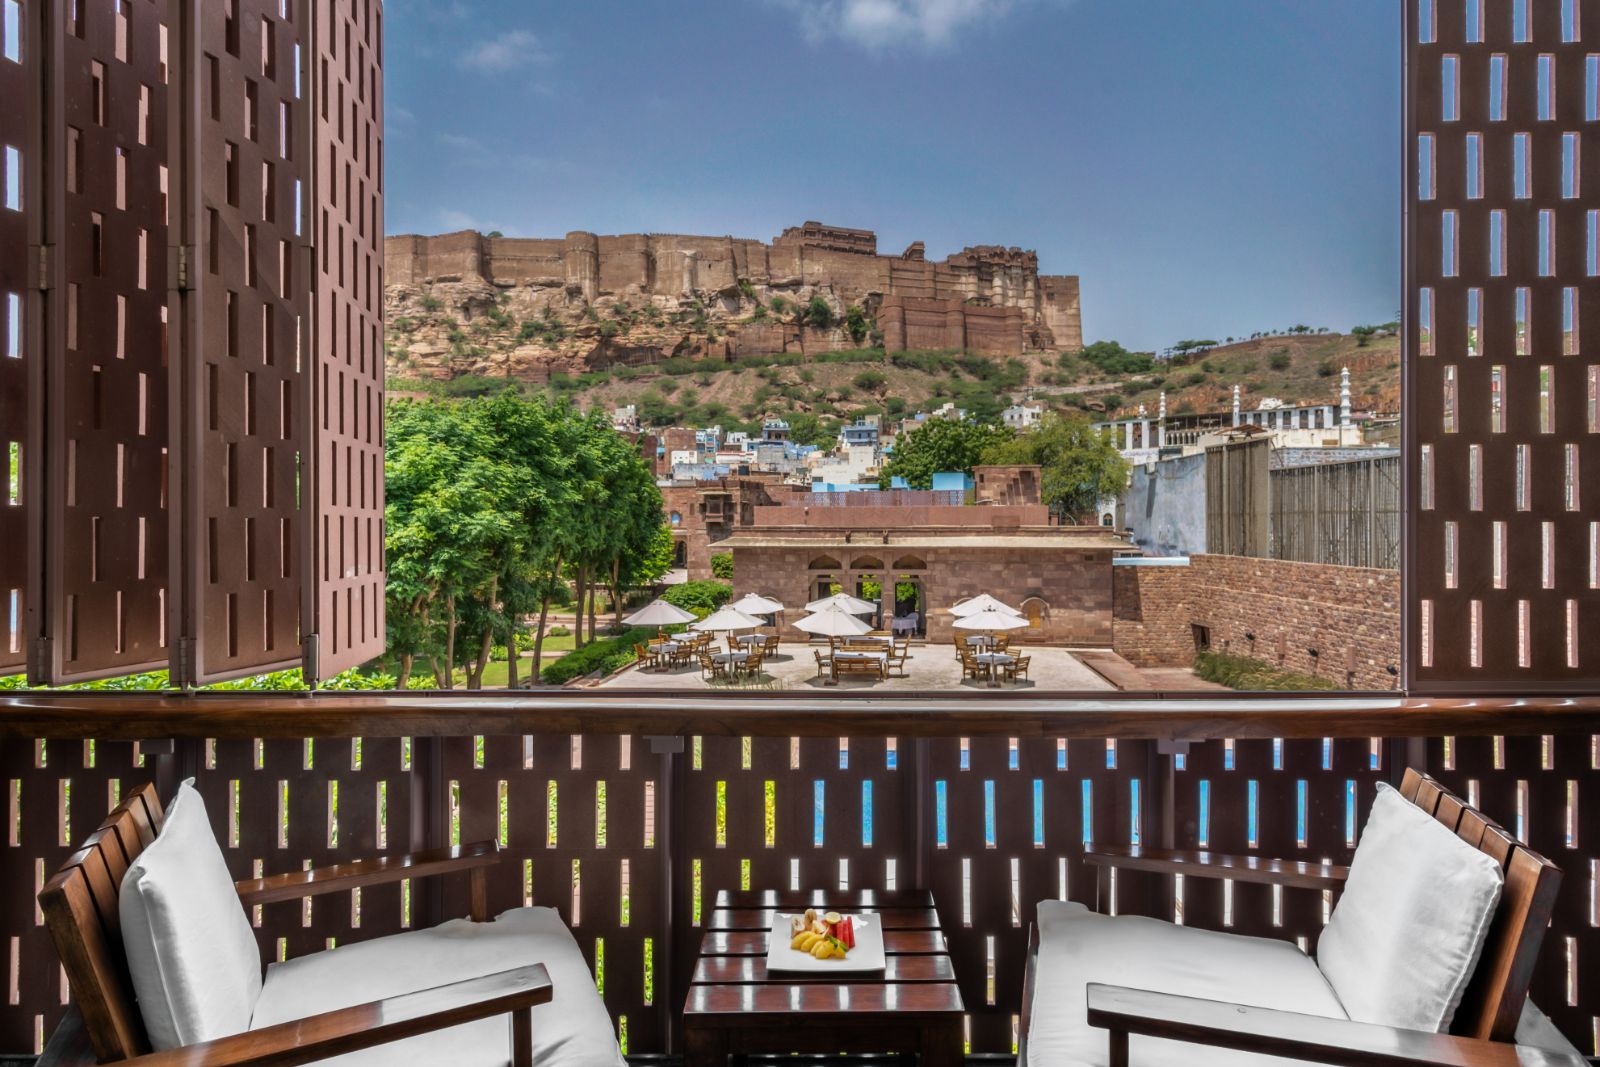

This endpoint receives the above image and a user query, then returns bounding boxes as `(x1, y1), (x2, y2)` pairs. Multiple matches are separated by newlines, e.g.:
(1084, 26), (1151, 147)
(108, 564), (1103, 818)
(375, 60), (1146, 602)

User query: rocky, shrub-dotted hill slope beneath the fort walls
(387, 279), (1400, 440)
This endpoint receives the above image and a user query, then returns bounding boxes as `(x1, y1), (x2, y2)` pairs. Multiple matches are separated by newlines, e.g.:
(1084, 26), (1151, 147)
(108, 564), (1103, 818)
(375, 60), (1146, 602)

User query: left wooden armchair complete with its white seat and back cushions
(38, 782), (622, 1067)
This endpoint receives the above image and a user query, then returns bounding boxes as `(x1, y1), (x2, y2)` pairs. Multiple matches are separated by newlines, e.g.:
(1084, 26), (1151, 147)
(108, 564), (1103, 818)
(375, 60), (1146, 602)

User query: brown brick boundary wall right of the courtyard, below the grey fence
(1112, 555), (1400, 689)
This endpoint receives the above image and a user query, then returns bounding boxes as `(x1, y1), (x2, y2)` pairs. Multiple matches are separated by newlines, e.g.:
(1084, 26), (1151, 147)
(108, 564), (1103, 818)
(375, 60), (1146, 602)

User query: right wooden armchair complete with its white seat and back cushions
(1018, 769), (1584, 1067)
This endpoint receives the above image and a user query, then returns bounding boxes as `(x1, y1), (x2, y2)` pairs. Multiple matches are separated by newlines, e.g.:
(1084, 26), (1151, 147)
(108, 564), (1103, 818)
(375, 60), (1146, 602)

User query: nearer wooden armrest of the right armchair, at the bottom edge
(1088, 984), (1586, 1067)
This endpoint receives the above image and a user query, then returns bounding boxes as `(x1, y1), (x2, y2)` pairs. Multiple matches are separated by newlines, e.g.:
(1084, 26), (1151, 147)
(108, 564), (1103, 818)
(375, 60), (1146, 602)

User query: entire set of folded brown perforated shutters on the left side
(0, 0), (382, 683)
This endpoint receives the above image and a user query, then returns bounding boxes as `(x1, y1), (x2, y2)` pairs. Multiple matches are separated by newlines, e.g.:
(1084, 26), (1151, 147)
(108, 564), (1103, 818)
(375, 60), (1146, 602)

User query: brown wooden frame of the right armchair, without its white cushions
(1018, 769), (1584, 1067)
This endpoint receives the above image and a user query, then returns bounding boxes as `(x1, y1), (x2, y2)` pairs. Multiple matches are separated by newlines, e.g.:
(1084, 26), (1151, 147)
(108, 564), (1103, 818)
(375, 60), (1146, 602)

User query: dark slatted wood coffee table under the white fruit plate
(683, 889), (966, 1067)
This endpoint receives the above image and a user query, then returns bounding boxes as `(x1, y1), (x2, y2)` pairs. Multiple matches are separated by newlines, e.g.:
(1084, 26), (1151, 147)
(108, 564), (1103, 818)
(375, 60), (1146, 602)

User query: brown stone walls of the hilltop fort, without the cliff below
(384, 222), (1083, 355)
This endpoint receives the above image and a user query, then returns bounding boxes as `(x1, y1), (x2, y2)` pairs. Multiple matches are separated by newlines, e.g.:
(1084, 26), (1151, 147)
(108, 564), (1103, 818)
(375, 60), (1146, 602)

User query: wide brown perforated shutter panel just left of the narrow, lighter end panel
(174, 0), (310, 681)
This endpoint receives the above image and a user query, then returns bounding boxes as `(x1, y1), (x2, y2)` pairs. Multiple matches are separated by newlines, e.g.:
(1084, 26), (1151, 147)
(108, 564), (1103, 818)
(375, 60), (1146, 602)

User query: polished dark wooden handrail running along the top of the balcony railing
(0, 691), (1600, 742)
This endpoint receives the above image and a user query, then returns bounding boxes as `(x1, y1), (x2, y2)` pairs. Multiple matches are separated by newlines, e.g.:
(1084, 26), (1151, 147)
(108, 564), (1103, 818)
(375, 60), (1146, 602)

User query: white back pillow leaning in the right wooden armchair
(1317, 784), (1506, 1033)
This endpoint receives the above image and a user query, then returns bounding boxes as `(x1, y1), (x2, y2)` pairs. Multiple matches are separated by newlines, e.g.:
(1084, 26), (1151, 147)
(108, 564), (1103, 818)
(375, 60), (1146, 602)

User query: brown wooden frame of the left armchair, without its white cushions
(38, 784), (554, 1067)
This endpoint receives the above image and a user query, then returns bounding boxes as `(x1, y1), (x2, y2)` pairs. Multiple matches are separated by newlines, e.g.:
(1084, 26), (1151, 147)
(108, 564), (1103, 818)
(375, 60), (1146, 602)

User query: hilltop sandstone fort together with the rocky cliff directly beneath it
(384, 222), (1083, 382)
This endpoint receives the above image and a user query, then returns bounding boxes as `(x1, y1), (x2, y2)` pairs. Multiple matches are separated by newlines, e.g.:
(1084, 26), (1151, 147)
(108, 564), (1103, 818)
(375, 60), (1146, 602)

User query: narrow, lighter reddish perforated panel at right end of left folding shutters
(306, 0), (384, 677)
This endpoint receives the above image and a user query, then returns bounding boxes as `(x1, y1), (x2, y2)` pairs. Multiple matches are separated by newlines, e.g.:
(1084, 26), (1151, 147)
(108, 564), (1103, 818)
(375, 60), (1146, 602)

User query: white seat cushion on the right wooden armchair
(1026, 901), (1344, 1067)
